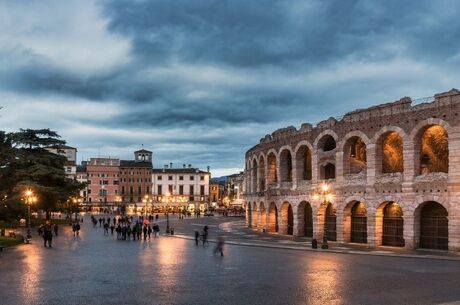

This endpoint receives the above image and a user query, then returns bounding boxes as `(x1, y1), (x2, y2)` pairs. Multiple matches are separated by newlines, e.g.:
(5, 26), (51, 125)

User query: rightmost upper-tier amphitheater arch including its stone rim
(410, 118), (449, 175)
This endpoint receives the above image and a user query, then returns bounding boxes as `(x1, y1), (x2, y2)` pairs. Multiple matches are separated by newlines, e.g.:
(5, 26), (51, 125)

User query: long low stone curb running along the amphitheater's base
(167, 234), (460, 261)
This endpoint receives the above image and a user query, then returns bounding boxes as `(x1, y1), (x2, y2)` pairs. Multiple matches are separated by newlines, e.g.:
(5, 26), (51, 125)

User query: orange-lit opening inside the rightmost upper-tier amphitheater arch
(414, 125), (449, 175)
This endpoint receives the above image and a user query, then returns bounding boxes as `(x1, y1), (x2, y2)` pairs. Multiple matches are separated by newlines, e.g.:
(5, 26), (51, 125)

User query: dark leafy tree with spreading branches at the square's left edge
(0, 129), (84, 218)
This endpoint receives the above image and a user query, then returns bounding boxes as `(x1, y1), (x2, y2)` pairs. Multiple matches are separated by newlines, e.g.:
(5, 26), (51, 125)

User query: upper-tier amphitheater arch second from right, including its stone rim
(374, 126), (407, 174)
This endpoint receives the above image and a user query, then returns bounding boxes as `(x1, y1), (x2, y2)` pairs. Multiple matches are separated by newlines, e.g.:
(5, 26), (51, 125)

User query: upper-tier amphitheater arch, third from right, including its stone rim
(341, 131), (369, 175)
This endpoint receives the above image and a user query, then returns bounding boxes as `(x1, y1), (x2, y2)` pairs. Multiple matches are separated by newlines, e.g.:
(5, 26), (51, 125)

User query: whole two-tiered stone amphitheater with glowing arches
(244, 89), (460, 252)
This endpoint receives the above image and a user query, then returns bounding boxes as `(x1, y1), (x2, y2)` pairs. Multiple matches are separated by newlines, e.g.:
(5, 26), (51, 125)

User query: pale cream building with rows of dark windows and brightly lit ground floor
(152, 163), (210, 211)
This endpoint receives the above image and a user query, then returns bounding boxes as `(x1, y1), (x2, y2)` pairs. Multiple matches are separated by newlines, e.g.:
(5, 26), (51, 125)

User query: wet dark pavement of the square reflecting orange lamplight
(0, 214), (460, 305)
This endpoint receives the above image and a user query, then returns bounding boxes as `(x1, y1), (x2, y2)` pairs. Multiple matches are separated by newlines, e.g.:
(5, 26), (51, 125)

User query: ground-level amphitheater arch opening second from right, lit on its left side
(375, 201), (404, 247)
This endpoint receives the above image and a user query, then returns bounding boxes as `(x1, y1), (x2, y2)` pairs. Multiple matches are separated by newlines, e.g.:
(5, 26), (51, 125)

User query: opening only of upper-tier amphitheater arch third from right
(343, 136), (367, 174)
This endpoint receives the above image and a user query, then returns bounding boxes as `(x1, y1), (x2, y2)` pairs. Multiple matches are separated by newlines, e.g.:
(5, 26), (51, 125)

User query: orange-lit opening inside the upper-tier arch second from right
(376, 131), (404, 174)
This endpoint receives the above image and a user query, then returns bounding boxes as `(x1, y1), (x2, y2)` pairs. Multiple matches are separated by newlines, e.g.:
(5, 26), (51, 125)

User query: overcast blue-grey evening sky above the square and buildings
(0, 0), (460, 176)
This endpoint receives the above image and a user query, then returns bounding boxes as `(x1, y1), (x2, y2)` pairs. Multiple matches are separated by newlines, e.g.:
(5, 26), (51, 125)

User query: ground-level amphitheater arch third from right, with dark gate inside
(343, 200), (367, 244)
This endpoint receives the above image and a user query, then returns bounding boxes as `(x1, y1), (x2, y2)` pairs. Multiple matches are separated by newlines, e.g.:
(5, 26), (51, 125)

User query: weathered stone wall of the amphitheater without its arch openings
(245, 89), (460, 251)
